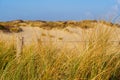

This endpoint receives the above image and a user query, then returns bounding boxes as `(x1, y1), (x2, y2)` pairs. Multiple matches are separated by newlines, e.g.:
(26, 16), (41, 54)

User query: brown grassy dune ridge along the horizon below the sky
(0, 20), (120, 32)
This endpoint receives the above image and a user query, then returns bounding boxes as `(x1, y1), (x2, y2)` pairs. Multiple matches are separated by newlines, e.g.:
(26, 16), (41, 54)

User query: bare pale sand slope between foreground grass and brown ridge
(0, 25), (120, 46)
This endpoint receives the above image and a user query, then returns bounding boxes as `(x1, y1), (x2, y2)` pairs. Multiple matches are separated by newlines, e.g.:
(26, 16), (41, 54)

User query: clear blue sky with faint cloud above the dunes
(0, 0), (120, 21)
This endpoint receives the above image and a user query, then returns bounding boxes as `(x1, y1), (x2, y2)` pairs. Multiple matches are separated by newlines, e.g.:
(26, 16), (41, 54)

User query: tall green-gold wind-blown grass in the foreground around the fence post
(0, 28), (120, 80)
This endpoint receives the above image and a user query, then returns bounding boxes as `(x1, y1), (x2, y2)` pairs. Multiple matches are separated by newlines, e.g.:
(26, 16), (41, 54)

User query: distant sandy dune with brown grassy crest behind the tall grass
(0, 20), (120, 46)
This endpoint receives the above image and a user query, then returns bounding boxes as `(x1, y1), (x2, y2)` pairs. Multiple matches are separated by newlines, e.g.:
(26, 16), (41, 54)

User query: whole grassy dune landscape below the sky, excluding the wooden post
(0, 20), (120, 80)
